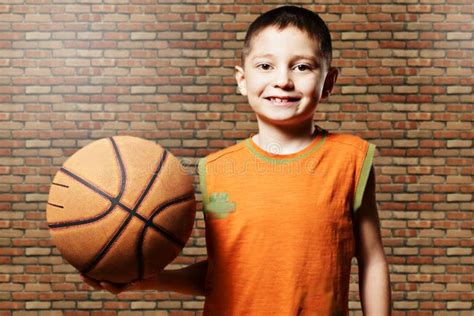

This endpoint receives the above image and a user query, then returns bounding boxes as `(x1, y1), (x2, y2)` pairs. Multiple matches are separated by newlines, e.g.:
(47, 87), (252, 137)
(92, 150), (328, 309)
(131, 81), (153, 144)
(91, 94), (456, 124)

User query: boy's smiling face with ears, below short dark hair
(235, 27), (337, 126)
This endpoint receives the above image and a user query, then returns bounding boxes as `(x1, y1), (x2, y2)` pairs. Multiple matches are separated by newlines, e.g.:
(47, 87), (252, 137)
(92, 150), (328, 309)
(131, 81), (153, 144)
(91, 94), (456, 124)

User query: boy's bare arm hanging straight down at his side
(354, 167), (391, 316)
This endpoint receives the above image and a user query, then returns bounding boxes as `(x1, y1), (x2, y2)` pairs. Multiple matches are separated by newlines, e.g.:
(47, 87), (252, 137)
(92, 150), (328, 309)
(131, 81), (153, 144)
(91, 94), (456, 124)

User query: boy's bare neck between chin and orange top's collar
(253, 120), (316, 155)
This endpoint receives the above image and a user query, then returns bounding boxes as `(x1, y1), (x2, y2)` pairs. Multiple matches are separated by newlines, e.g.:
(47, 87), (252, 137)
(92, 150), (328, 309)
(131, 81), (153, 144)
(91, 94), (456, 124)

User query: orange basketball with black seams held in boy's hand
(46, 136), (196, 283)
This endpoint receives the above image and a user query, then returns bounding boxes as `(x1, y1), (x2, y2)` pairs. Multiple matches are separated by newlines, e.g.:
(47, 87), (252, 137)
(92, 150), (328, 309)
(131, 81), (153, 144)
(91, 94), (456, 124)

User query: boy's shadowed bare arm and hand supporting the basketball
(82, 260), (207, 296)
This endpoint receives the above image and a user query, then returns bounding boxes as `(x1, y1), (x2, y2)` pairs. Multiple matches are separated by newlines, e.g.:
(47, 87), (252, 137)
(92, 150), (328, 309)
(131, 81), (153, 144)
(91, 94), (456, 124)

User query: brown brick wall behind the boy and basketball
(0, 0), (473, 315)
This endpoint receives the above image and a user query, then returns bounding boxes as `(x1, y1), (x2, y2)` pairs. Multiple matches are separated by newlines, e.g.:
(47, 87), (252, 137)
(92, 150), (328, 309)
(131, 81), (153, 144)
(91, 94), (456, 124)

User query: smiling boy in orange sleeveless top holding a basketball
(85, 6), (390, 316)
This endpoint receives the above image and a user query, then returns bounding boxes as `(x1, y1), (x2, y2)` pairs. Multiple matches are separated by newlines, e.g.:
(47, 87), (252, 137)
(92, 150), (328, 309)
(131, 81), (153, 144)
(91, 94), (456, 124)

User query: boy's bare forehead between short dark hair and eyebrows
(248, 26), (320, 57)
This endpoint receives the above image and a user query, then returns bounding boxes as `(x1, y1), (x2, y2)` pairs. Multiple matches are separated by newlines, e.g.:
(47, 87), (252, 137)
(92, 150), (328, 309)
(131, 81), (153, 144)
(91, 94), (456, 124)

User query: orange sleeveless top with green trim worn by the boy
(199, 127), (375, 316)
